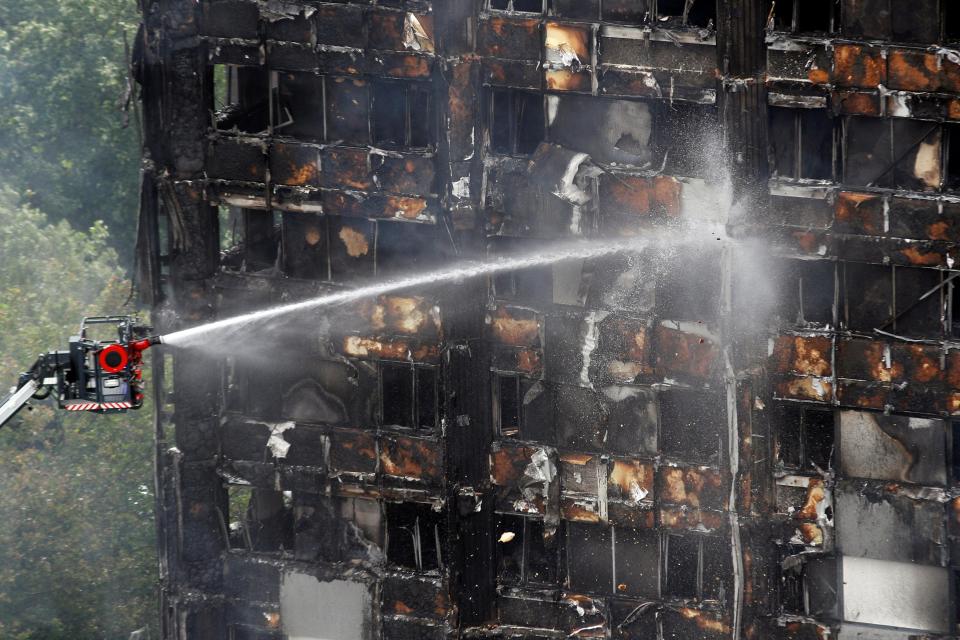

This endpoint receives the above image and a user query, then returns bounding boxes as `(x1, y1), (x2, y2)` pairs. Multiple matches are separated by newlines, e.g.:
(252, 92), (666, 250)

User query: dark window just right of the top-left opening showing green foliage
(273, 72), (325, 140)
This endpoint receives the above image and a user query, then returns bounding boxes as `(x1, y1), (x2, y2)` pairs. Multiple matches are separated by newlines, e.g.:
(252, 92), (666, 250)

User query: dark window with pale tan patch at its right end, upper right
(843, 117), (942, 191)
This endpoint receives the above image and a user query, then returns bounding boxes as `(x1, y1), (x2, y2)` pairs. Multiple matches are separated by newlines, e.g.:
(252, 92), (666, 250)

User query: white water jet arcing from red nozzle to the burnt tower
(161, 228), (719, 347)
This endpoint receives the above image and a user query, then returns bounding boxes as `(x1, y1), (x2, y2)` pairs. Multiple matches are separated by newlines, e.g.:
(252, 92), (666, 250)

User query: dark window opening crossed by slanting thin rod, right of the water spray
(887, 267), (944, 338)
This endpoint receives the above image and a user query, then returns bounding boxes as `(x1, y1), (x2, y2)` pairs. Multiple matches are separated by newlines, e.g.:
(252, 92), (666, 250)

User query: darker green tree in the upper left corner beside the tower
(0, 0), (140, 268)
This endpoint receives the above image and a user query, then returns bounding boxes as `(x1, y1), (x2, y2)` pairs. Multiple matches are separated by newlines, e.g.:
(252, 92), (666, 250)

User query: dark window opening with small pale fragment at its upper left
(496, 515), (560, 584)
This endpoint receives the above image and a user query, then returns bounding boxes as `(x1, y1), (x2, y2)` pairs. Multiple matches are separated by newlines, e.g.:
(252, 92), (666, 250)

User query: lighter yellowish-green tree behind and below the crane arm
(0, 189), (156, 640)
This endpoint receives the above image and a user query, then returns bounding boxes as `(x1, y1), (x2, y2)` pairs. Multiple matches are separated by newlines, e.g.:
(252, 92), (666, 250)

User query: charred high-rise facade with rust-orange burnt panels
(136, 0), (960, 640)
